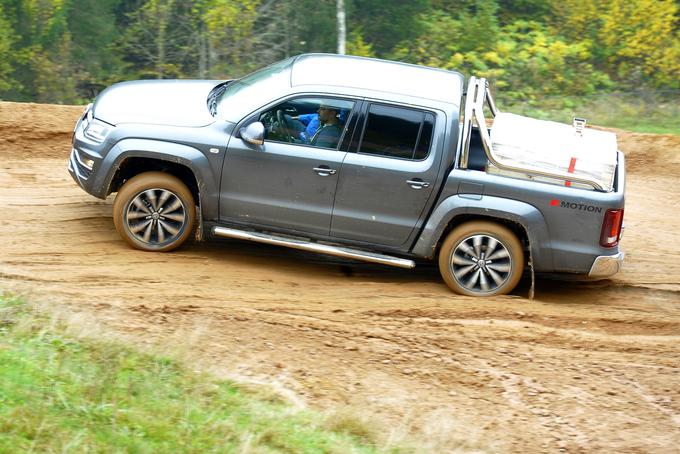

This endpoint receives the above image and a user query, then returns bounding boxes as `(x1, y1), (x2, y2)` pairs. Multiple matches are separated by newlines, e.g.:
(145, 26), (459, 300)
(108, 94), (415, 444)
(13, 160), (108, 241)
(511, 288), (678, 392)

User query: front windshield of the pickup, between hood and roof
(217, 57), (294, 123)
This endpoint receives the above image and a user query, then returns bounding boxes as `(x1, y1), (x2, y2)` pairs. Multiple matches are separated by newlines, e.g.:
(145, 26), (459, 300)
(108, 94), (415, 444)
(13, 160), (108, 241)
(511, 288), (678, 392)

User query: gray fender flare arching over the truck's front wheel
(94, 139), (219, 219)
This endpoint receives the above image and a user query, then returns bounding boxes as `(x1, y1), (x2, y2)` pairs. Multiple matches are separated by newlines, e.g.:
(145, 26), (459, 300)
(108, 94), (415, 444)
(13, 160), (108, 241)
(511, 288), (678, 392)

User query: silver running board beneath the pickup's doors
(213, 227), (416, 268)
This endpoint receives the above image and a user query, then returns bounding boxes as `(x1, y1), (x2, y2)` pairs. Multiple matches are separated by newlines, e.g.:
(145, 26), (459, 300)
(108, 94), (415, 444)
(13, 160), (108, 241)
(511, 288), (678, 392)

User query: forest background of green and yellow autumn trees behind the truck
(0, 0), (680, 134)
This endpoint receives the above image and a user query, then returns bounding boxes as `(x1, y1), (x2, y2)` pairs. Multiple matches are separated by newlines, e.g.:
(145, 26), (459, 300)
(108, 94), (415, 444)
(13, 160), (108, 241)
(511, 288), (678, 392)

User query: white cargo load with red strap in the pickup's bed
(488, 112), (618, 192)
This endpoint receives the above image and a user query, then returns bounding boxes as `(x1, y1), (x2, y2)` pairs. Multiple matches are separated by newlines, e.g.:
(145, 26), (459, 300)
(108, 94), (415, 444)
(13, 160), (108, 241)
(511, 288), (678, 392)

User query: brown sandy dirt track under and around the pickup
(0, 103), (680, 452)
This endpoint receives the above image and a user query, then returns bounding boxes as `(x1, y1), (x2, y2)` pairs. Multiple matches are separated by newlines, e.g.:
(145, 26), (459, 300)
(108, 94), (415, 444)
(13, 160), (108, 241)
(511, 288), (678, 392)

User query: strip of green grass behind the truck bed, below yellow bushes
(499, 92), (680, 135)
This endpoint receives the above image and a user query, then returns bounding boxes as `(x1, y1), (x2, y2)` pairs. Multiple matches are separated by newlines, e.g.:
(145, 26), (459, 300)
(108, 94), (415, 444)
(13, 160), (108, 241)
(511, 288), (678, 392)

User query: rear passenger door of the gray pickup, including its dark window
(331, 102), (444, 247)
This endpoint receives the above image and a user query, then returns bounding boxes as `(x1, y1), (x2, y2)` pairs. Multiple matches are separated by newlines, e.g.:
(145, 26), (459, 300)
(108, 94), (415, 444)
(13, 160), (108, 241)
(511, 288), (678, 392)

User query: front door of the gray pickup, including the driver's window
(220, 97), (354, 235)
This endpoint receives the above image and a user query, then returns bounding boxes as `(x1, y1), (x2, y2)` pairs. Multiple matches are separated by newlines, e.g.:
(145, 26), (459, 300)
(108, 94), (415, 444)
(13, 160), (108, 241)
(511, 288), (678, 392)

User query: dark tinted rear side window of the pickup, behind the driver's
(359, 104), (434, 160)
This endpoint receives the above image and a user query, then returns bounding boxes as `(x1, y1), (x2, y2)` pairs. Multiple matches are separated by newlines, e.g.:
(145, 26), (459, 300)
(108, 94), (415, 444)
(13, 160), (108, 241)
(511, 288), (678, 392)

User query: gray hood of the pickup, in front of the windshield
(93, 80), (222, 127)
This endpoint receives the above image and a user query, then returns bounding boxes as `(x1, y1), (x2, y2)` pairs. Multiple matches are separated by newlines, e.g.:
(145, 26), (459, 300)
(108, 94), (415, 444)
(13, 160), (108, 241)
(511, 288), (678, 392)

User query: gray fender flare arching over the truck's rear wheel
(412, 194), (553, 272)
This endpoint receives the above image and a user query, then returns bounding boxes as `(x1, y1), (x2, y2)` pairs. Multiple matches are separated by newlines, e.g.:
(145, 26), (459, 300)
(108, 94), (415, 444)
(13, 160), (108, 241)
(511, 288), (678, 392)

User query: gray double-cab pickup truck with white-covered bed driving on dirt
(68, 54), (625, 296)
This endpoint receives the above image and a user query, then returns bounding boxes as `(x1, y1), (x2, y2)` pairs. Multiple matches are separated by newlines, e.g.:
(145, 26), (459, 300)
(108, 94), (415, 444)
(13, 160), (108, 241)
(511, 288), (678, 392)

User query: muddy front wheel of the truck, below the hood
(113, 172), (196, 252)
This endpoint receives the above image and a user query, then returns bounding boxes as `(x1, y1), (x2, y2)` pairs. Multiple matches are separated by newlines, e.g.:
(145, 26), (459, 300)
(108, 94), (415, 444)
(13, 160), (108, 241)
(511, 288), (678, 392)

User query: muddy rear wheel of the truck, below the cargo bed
(439, 221), (524, 296)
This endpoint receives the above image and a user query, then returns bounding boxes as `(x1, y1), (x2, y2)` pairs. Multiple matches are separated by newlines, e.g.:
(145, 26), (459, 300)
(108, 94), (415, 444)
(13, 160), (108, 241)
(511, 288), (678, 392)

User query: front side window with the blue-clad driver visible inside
(259, 97), (354, 149)
